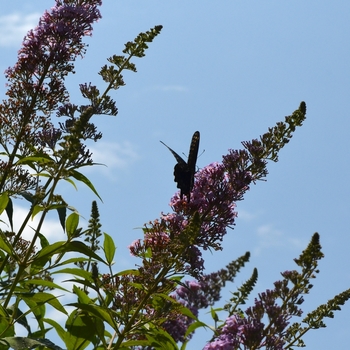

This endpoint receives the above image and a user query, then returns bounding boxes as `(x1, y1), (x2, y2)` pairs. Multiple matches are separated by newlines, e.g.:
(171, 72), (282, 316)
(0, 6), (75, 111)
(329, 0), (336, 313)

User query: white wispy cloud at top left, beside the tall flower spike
(0, 13), (41, 47)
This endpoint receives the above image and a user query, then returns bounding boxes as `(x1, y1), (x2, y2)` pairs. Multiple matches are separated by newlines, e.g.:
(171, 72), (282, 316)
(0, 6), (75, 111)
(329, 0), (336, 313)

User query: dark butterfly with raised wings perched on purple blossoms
(160, 131), (200, 202)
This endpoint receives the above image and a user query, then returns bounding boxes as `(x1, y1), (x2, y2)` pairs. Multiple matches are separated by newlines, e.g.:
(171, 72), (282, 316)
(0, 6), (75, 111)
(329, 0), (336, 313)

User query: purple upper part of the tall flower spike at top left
(6, 0), (101, 114)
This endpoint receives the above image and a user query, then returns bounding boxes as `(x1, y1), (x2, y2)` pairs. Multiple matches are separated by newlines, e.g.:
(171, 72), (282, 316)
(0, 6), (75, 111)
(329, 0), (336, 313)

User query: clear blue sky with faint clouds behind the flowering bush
(0, 0), (350, 350)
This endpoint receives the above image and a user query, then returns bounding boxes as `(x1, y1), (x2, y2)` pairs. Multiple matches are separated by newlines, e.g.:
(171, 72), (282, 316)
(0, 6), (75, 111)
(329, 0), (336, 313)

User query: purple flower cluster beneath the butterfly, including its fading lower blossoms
(129, 146), (252, 277)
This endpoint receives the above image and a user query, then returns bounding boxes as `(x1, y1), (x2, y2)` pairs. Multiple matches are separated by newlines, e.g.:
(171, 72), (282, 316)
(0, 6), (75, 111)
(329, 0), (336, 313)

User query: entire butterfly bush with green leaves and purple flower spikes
(0, 0), (350, 350)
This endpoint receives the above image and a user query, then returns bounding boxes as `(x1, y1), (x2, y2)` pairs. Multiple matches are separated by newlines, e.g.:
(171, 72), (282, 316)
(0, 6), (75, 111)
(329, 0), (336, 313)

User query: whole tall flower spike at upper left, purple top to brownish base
(0, 0), (102, 191)
